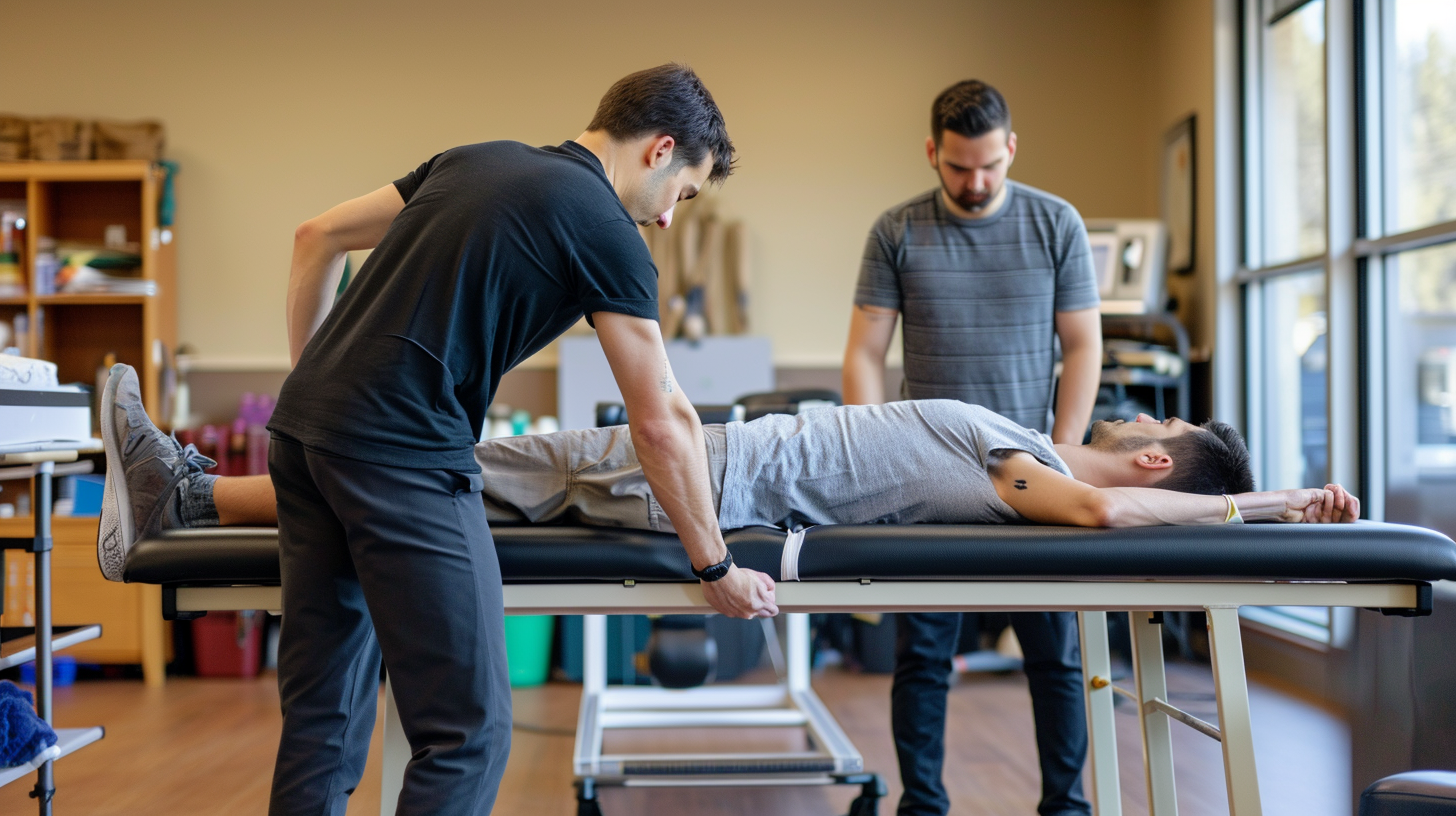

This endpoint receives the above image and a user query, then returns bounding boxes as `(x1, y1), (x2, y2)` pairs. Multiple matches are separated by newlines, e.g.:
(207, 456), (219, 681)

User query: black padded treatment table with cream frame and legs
(125, 522), (1456, 816)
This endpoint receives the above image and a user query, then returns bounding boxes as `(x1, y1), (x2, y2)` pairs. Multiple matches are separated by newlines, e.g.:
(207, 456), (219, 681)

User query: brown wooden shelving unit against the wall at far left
(0, 160), (176, 685)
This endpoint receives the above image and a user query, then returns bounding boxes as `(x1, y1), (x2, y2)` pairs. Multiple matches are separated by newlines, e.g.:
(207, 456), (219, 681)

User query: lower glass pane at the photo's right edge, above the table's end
(1385, 243), (1456, 535)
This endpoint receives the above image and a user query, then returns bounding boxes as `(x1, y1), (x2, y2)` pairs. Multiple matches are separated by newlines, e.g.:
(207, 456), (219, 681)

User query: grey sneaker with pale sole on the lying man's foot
(96, 363), (217, 581)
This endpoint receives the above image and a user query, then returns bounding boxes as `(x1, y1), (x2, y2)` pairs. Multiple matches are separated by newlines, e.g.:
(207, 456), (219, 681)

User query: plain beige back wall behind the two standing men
(3, 0), (1170, 364)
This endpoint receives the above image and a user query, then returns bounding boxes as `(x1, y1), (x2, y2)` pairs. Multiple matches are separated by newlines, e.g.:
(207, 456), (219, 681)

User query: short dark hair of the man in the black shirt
(587, 63), (734, 184)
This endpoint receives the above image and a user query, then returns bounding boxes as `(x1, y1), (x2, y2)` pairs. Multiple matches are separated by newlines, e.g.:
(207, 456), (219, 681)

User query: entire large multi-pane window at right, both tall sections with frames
(1219, 0), (1456, 641)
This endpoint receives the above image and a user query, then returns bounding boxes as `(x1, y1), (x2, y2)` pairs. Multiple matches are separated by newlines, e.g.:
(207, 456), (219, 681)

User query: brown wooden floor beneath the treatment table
(0, 664), (1351, 816)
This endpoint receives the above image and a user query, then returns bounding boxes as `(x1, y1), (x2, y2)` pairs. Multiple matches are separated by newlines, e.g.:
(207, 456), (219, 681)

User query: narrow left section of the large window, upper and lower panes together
(1245, 0), (1329, 490)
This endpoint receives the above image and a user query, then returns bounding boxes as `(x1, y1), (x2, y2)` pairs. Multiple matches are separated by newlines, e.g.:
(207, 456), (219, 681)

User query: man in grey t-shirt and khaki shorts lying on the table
(99, 362), (1360, 580)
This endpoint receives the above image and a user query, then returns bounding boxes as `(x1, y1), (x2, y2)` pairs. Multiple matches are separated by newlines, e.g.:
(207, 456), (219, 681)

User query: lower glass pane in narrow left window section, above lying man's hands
(1257, 271), (1329, 490)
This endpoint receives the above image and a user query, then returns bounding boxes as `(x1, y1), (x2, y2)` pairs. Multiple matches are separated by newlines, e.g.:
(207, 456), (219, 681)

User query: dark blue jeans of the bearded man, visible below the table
(890, 612), (1092, 816)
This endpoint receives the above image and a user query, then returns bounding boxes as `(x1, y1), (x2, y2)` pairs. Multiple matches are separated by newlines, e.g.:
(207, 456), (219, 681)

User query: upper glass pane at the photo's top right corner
(1385, 0), (1456, 232)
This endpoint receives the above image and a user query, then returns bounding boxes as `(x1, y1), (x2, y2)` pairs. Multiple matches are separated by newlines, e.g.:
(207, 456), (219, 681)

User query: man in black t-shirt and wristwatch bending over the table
(268, 66), (778, 815)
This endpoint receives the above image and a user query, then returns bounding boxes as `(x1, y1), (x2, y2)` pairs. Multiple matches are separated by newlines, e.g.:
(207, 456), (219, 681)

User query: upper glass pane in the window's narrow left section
(1261, 0), (1325, 265)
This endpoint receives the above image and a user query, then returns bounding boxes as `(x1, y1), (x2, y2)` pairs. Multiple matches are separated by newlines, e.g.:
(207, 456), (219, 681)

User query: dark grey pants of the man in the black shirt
(268, 436), (511, 816)
